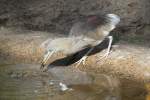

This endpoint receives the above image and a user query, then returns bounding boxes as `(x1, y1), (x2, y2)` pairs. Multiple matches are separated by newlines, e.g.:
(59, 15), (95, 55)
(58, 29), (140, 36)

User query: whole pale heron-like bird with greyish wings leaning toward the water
(41, 14), (120, 69)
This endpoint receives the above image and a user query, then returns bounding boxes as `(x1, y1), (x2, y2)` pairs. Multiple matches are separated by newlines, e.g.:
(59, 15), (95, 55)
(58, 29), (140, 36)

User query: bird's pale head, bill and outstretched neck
(41, 36), (94, 71)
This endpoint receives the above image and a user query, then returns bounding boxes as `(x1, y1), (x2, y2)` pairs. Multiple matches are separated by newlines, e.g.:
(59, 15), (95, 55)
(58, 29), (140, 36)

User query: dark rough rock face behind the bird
(0, 0), (150, 33)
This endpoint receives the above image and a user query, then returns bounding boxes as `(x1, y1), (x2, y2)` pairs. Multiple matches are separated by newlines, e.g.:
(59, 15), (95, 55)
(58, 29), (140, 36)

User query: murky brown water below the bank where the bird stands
(0, 64), (148, 100)
